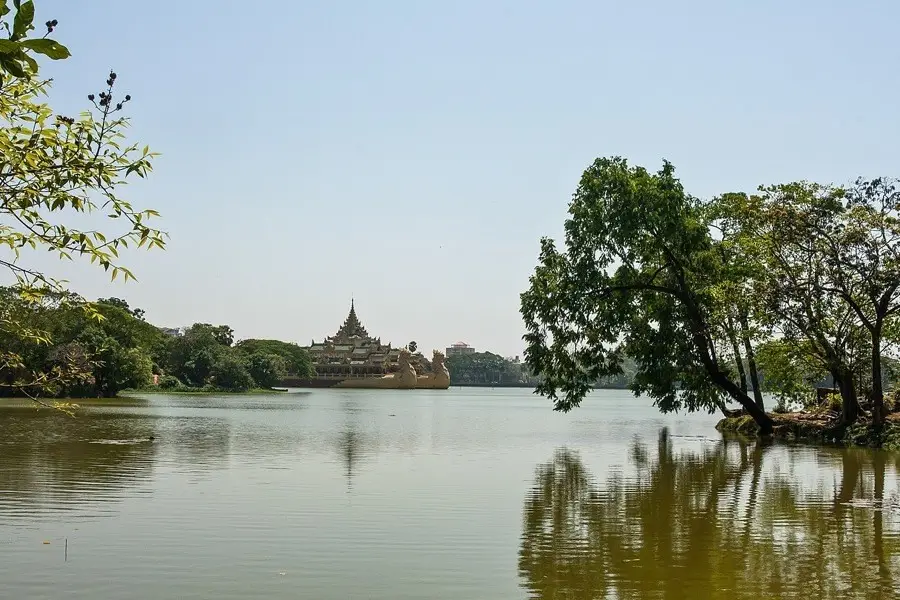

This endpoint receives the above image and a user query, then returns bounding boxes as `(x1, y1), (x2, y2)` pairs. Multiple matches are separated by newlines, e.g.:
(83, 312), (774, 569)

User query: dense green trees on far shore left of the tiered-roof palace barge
(0, 288), (313, 398)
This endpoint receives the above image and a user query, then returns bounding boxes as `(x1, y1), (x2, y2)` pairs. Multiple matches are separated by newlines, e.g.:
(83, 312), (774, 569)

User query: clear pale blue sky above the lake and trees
(19, 0), (900, 355)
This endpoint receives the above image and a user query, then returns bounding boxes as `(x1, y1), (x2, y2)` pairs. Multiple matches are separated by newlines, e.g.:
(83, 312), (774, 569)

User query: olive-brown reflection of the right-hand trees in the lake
(519, 430), (900, 599)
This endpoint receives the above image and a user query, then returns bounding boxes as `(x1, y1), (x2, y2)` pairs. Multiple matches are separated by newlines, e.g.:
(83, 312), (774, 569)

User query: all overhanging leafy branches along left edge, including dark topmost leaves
(0, 0), (165, 404)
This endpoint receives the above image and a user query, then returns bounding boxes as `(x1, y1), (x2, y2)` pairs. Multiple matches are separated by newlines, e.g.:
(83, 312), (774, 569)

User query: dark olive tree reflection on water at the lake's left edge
(0, 407), (158, 521)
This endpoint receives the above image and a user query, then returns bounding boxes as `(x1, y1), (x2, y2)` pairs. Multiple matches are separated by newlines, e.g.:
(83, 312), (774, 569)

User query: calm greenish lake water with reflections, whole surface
(0, 389), (900, 600)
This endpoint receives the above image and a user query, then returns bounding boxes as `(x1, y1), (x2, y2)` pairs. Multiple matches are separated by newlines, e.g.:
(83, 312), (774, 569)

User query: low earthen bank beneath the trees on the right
(716, 412), (900, 451)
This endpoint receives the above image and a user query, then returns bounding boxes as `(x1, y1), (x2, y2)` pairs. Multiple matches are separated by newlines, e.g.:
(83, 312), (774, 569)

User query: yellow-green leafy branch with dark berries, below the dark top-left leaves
(0, 65), (165, 290)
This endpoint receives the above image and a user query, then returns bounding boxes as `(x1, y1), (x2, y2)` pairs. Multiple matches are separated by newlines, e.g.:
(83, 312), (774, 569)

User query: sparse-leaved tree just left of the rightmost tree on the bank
(729, 182), (868, 424)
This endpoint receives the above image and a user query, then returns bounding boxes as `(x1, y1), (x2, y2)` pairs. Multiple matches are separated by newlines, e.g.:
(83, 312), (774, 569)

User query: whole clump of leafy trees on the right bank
(521, 158), (900, 431)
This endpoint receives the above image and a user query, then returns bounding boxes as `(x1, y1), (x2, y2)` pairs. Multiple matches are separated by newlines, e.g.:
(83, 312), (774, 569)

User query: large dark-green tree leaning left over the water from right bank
(521, 158), (773, 433)
